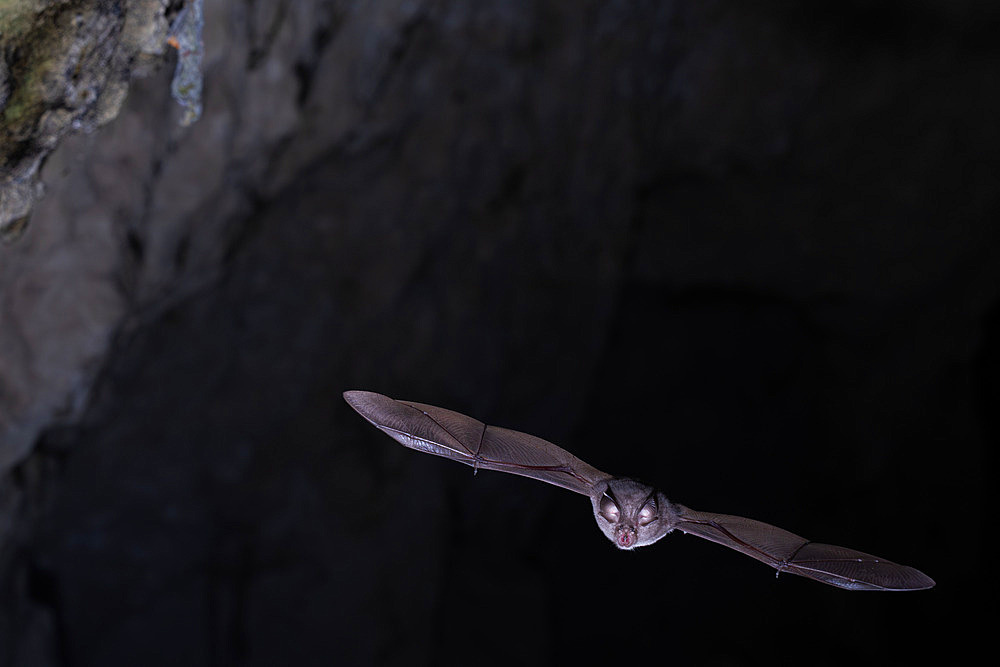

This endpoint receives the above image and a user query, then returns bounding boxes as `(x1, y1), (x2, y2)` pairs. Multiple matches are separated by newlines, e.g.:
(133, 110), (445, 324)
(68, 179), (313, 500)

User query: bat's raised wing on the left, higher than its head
(344, 391), (610, 496)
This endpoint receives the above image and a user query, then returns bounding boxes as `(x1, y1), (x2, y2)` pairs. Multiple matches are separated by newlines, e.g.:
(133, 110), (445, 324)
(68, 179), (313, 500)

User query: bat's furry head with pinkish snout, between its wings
(591, 477), (673, 549)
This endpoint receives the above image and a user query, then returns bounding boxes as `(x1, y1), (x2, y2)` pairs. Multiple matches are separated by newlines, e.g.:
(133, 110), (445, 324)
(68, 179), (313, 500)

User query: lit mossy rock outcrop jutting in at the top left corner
(0, 0), (171, 242)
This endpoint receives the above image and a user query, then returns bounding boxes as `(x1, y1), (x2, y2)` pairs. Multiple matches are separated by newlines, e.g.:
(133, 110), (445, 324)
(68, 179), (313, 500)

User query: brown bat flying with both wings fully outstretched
(344, 391), (934, 591)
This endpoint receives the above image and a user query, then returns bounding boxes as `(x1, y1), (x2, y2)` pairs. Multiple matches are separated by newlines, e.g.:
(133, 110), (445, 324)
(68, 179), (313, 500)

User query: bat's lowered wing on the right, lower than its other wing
(674, 505), (934, 591)
